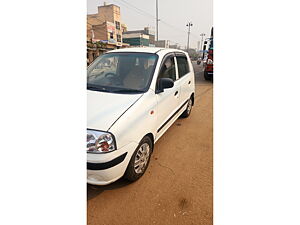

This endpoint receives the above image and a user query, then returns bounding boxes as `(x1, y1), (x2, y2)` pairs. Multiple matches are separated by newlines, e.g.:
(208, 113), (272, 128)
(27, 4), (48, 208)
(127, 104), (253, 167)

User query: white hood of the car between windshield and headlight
(87, 90), (143, 131)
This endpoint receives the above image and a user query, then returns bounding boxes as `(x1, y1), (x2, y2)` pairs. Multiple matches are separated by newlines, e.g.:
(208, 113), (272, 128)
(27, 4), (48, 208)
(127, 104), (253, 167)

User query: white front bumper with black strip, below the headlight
(87, 142), (138, 185)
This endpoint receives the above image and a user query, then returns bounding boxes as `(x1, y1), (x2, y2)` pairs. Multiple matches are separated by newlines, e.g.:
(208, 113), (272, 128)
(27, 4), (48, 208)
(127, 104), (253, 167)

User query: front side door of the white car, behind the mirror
(156, 54), (180, 138)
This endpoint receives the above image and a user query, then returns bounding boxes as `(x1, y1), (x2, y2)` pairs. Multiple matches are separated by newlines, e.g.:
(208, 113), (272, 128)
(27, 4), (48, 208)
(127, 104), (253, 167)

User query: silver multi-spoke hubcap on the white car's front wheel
(134, 143), (150, 173)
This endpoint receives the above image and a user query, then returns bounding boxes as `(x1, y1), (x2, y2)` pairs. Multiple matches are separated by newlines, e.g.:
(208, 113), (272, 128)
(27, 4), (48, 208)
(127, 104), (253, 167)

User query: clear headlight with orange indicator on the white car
(86, 130), (116, 153)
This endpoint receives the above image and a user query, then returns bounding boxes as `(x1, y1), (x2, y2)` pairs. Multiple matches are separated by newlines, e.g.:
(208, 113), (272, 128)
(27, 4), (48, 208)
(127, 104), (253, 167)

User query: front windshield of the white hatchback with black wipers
(87, 52), (158, 93)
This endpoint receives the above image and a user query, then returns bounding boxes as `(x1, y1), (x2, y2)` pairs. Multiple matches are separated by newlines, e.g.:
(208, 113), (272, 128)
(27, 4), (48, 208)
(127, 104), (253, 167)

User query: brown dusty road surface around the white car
(87, 63), (213, 225)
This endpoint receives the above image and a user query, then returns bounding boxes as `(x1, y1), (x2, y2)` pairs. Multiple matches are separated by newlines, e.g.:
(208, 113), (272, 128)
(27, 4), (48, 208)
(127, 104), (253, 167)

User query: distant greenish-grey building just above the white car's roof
(123, 27), (155, 47)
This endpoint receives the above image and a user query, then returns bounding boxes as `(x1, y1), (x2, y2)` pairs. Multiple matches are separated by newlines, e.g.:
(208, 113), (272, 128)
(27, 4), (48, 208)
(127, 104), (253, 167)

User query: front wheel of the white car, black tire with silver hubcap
(124, 136), (153, 182)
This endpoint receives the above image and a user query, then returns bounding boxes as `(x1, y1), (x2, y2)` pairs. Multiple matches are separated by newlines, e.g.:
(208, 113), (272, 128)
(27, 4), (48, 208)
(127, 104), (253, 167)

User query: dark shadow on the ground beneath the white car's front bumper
(87, 177), (131, 200)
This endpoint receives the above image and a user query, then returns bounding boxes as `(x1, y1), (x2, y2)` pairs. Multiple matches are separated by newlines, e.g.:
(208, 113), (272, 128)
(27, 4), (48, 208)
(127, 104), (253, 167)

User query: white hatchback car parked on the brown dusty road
(87, 48), (195, 185)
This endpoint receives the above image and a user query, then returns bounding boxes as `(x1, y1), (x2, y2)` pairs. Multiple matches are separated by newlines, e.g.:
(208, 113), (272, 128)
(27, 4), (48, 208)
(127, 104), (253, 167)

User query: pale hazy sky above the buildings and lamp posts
(87, 0), (213, 48)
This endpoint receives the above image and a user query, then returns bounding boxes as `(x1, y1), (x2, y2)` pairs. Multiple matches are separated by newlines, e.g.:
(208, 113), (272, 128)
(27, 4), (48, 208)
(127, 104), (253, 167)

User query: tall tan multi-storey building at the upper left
(87, 3), (128, 49)
